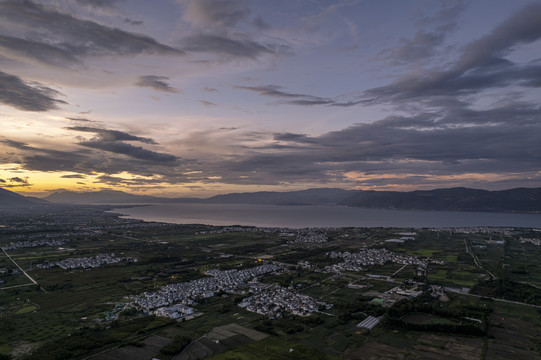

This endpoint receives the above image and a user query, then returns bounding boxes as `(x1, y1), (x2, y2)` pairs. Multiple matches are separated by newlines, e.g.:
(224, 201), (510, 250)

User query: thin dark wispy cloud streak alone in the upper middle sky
(234, 85), (364, 107)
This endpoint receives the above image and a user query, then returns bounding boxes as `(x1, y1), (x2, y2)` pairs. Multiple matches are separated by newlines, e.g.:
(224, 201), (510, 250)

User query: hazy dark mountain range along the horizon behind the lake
(0, 188), (541, 213)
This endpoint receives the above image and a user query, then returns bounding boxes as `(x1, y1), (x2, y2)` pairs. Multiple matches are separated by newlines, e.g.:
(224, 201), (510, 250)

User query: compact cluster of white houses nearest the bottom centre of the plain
(239, 284), (332, 318)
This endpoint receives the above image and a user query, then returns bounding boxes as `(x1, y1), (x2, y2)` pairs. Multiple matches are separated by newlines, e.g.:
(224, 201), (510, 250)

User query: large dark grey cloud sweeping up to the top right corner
(366, 3), (541, 102)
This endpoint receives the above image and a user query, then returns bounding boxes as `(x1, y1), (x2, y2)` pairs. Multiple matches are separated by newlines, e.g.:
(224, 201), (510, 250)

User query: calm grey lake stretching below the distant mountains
(114, 204), (541, 228)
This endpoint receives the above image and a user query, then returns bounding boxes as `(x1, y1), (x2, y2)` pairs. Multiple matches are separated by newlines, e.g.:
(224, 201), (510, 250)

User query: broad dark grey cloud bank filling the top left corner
(0, 0), (183, 66)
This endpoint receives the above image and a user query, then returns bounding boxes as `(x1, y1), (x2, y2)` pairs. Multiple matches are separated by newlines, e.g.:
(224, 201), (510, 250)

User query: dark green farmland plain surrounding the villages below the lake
(0, 206), (541, 360)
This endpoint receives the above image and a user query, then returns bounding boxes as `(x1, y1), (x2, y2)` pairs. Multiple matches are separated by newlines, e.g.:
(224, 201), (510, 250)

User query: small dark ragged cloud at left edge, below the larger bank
(0, 71), (66, 111)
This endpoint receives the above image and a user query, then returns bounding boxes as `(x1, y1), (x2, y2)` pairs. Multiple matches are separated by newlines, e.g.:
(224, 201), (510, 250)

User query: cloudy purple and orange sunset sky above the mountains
(0, 0), (541, 197)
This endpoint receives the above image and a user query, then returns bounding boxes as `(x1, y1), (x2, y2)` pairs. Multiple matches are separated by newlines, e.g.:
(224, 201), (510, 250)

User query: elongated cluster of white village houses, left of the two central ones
(133, 264), (281, 313)
